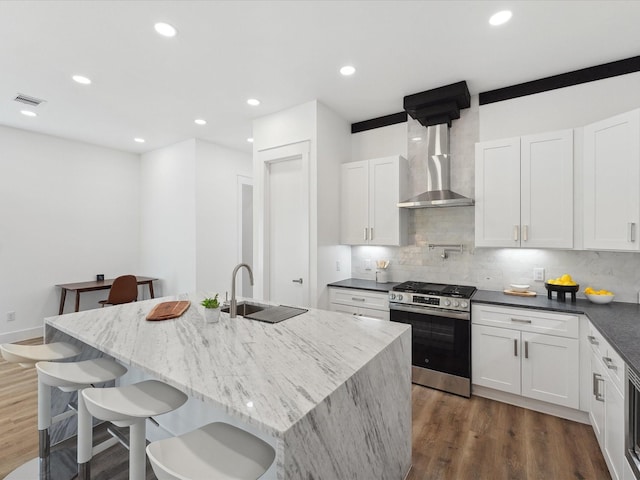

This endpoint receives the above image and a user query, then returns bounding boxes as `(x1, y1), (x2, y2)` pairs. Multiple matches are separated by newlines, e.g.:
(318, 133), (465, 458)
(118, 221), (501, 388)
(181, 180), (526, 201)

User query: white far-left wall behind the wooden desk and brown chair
(0, 126), (140, 342)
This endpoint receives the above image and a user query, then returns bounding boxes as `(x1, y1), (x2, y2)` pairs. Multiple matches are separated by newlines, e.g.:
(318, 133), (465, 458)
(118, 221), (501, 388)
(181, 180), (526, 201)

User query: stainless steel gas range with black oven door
(389, 282), (476, 397)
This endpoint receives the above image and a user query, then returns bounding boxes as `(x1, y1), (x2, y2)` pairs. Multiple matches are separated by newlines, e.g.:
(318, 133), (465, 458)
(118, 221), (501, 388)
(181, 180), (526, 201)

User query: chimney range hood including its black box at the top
(398, 81), (473, 208)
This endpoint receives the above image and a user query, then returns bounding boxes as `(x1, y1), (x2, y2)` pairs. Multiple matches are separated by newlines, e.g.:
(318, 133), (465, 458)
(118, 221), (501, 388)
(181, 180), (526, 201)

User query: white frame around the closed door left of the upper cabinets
(253, 141), (314, 306)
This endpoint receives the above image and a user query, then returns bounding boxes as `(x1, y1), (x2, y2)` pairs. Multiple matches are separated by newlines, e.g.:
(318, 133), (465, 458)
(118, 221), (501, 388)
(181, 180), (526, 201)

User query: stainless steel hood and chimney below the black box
(398, 123), (473, 208)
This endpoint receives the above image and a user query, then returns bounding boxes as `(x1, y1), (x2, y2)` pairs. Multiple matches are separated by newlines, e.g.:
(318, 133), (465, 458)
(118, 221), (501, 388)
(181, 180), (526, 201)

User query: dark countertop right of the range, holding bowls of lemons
(471, 290), (640, 375)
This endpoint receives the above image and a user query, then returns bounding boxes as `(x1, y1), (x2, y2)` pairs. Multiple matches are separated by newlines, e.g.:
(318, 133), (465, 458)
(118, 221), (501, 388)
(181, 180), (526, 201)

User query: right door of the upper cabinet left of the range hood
(369, 157), (401, 245)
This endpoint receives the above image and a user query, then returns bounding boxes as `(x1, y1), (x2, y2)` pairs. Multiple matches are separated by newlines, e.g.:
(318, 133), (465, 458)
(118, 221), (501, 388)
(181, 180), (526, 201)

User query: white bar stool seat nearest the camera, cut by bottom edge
(147, 422), (276, 480)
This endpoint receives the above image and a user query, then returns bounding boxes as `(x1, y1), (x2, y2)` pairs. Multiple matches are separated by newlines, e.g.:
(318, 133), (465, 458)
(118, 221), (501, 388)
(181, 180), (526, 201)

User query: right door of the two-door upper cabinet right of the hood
(520, 130), (573, 248)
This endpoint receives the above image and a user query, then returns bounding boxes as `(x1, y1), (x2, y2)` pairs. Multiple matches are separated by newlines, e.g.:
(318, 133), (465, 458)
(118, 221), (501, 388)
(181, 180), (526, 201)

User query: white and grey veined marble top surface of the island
(46, 293), (410, 450)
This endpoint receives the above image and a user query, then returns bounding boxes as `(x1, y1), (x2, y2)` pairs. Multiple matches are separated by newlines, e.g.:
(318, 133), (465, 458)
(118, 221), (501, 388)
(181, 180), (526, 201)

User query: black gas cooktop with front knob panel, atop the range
(389, 282), (476, 312)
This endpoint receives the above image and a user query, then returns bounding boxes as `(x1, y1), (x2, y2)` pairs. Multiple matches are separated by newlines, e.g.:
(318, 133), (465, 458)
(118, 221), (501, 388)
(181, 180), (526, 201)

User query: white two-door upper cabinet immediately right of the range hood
(475, 130), (573, 248)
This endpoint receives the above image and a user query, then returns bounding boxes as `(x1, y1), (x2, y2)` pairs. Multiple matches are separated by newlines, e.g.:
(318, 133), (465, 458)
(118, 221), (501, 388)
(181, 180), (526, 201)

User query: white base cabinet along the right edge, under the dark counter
(588, 326), (626, 480)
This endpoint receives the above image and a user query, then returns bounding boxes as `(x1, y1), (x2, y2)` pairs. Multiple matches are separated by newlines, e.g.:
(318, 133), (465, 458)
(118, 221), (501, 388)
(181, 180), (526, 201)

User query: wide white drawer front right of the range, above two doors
(471, 304), (579, 338)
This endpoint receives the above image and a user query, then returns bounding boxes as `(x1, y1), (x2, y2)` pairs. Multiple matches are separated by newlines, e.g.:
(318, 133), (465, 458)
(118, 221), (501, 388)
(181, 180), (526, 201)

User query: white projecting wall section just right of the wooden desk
(140, 139), (196, 297)
